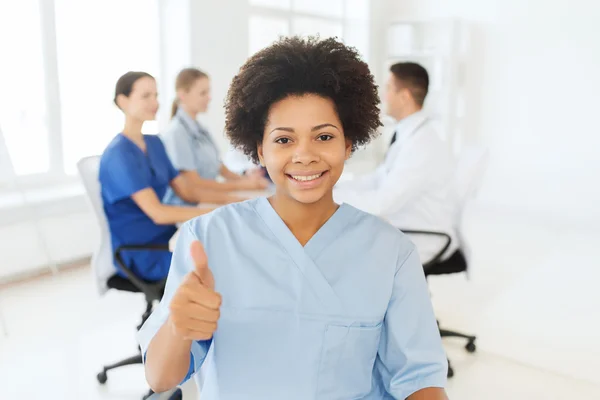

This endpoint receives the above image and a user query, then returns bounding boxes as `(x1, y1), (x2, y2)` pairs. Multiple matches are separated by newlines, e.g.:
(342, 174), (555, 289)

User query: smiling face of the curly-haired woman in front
(258, 95), (352, 204)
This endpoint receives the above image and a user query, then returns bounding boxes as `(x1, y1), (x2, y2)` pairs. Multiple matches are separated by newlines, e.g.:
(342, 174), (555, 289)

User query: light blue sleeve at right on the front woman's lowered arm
(377, 246), (448, 399)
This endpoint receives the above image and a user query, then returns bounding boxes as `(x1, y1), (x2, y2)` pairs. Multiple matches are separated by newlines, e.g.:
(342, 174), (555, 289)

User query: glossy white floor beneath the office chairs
(0, 208), (600, 400)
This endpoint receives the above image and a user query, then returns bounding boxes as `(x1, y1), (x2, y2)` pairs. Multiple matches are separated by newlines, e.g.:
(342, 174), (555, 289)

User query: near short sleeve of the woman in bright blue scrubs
(99, 147), (152, 203)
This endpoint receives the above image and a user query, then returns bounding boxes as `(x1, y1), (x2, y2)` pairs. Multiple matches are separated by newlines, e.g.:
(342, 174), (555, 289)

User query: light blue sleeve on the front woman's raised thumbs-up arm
(137, 222), (212, 383)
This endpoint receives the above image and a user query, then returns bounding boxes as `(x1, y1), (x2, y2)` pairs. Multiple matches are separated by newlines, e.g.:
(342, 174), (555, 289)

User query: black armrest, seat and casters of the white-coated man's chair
(402, 230), (477, 378)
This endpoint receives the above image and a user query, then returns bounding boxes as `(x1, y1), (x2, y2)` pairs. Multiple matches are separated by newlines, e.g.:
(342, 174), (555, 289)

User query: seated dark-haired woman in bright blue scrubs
(98, 72), (223, 281)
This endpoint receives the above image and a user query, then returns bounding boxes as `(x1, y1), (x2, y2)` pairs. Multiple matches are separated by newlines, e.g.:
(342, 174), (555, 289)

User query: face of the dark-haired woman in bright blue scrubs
(117, 77), (158, 122)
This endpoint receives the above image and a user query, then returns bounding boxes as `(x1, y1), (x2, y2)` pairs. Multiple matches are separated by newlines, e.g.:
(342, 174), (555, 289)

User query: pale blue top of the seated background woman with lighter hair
(160, 108), (222, 205)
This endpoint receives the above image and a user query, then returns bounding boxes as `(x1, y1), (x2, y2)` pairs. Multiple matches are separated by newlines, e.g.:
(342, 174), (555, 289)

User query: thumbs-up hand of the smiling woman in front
(169, 241), (221, 340)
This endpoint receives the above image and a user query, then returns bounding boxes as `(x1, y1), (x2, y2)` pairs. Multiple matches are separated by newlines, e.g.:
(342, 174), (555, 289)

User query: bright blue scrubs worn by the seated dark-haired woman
(98, 134), (178, 281)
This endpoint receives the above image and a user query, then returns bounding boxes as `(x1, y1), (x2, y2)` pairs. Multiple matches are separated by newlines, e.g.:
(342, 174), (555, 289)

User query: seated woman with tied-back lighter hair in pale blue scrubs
(160, 68), (269, 204)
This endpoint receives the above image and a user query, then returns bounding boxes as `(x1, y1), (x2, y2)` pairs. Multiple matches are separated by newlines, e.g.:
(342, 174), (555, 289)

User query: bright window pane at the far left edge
(0, 0), (50, 179)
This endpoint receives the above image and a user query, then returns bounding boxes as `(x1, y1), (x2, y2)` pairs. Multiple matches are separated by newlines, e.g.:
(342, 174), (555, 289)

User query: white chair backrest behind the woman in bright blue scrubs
(77, 156), (116, 294)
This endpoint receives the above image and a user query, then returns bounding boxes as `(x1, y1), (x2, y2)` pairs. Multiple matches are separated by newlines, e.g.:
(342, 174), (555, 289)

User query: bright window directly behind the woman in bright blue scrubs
(55, 0), (160, 174)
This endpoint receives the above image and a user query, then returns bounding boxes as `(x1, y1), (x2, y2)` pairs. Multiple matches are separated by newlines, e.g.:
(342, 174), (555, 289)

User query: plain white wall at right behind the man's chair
(388, 0), (600, 227)
